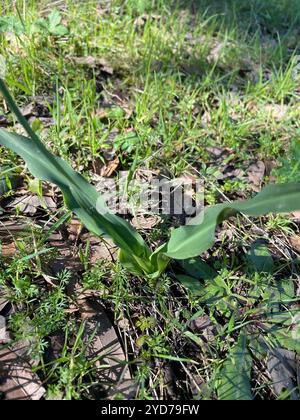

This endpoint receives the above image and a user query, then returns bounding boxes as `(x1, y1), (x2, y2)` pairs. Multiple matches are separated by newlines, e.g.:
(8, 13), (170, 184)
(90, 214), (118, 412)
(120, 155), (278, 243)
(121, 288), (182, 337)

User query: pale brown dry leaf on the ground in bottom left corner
(0, 348), (45, 400)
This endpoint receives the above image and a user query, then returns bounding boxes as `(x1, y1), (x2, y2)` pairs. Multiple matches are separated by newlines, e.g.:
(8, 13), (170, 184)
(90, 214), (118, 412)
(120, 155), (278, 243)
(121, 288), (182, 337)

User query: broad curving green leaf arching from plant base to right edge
(165, 183), (300, 260)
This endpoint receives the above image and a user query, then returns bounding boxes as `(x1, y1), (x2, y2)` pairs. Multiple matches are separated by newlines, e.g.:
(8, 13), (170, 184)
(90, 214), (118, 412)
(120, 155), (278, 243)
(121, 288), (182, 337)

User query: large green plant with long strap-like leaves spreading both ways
(0, 79), (300, 278)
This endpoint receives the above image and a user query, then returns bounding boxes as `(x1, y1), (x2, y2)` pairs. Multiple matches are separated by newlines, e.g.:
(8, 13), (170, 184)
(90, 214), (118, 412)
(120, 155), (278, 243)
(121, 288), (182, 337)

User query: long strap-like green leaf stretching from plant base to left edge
(0, 81), (151, 271)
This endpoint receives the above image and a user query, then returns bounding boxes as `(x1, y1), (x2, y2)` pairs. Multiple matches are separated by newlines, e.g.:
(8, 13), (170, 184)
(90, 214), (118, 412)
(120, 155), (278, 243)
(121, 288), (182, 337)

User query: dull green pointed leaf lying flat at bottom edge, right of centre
(216, 332), (253, 401)
